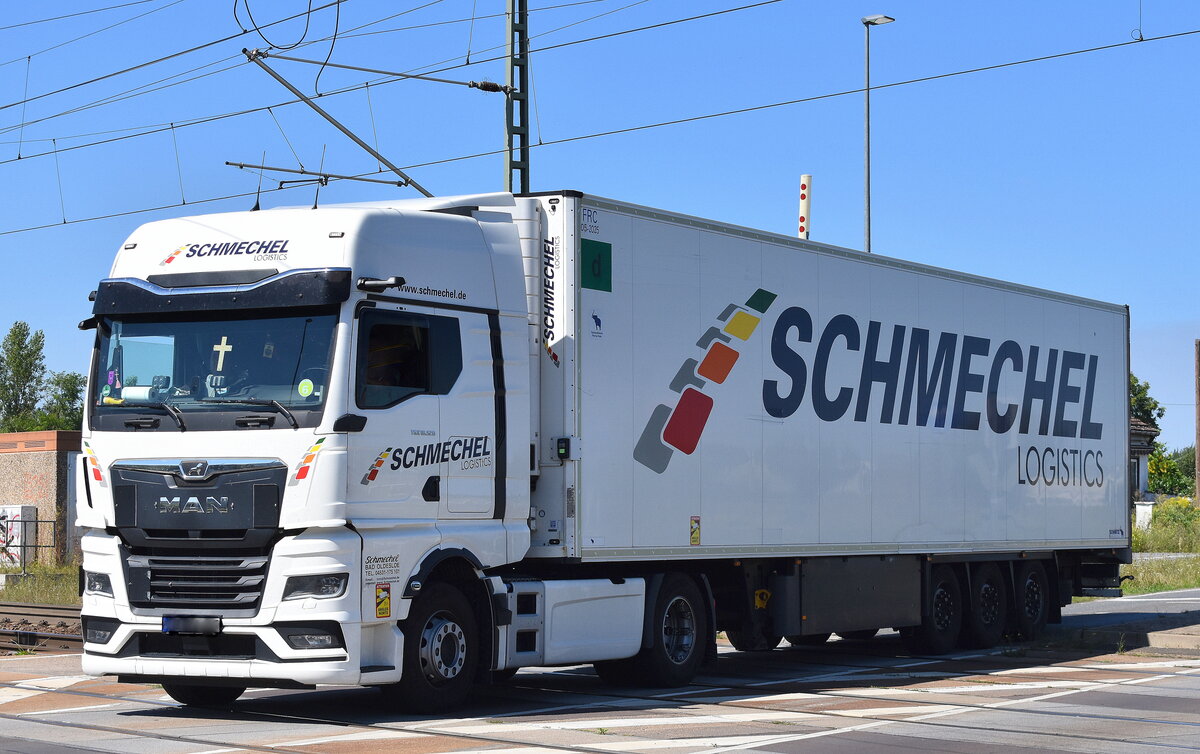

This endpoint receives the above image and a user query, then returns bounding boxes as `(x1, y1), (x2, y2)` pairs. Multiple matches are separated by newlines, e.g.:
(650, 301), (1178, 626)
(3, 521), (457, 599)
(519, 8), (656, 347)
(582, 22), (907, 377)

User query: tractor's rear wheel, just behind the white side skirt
(594, 573), (709, 687)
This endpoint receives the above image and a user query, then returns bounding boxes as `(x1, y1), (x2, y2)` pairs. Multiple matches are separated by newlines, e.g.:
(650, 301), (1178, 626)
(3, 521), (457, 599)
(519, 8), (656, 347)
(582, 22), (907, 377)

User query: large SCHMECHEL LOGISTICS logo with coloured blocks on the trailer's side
(634, 288), (1105, 487)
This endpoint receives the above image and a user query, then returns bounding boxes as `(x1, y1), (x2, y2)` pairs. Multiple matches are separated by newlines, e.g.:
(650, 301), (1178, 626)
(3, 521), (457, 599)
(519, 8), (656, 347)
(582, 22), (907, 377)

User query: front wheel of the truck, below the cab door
(384, 584), (480, 712)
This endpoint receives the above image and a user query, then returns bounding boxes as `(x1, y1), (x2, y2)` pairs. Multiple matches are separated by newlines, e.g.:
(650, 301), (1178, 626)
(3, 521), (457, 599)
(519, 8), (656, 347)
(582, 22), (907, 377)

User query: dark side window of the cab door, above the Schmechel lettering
(355, 310), (462, 408)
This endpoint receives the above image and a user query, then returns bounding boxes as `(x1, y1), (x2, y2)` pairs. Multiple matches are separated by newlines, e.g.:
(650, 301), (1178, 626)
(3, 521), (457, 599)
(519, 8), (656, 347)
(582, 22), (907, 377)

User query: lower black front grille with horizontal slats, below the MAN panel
(126, 555), (268, 617)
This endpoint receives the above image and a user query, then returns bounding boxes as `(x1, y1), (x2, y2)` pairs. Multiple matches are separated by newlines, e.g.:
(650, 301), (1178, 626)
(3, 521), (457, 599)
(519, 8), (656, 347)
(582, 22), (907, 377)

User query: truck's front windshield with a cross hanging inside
(90, 310), (337, 430)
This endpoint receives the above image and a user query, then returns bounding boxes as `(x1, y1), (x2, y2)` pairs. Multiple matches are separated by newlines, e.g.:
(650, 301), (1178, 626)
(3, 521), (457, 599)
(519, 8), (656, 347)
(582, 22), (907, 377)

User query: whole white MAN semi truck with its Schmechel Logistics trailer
(78, 191), (1130, 711)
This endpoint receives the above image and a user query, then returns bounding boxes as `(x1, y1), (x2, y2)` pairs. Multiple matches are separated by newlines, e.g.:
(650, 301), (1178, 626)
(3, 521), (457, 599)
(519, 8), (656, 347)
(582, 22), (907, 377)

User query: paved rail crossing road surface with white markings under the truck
(0, 590), (1200, 754)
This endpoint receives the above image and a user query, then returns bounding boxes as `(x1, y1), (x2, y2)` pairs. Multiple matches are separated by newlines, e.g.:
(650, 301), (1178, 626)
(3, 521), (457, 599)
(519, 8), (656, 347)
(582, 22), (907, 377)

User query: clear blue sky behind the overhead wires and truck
(0, 0), (1200, 447)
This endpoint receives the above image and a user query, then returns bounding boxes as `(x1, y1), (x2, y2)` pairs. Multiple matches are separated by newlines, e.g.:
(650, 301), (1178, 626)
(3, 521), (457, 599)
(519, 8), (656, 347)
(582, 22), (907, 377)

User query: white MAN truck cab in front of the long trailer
(79, 195), (585, 702)
